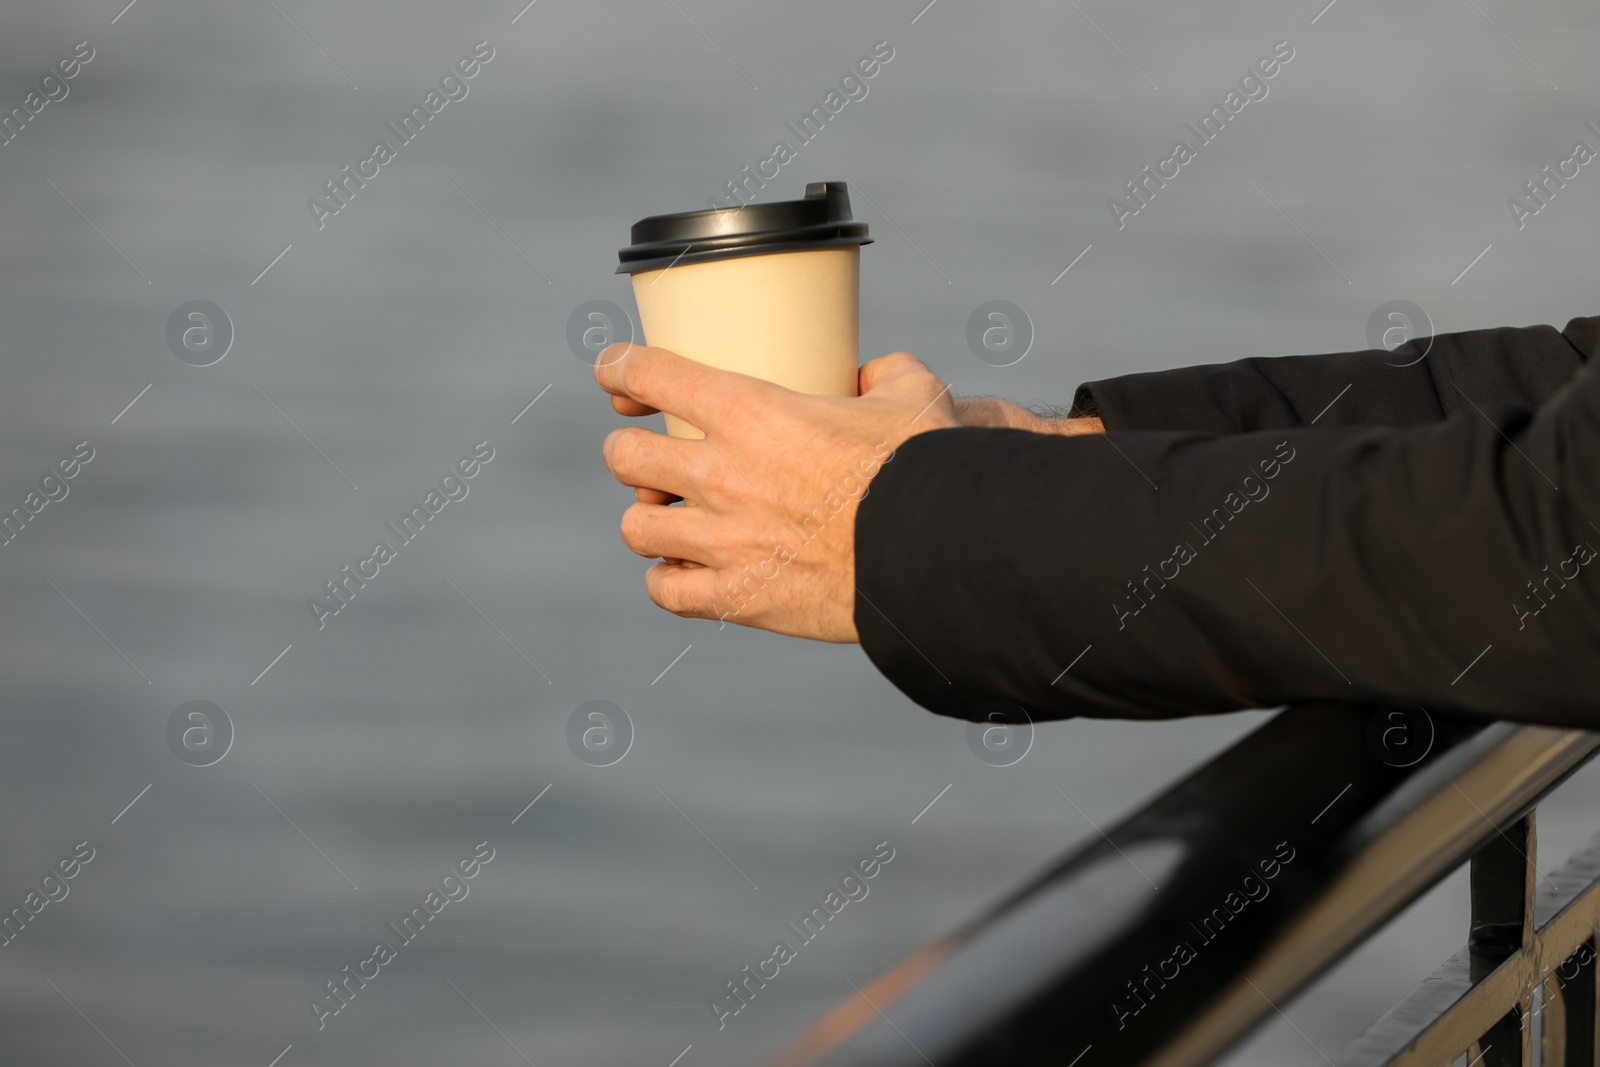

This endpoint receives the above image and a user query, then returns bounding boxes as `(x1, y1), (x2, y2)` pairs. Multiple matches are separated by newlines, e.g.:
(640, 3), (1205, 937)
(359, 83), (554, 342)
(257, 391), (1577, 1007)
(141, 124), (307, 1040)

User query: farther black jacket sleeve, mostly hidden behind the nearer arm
(1074, 318), (1600, 434)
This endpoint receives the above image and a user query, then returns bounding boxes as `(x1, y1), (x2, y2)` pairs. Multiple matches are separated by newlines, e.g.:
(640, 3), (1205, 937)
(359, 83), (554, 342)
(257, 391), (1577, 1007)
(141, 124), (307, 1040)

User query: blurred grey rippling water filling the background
(0, 0), (1600, 1067)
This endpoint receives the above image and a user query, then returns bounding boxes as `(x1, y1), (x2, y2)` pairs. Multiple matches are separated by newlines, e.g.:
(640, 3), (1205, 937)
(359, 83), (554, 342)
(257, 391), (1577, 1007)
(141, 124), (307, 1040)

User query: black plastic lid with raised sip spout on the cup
(616, 181), (872, 274)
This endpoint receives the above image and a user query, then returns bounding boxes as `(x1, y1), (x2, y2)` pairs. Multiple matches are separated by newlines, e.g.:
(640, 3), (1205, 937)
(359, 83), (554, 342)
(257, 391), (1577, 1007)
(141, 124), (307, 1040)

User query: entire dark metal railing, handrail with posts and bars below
(779, 705), (1600, 1067)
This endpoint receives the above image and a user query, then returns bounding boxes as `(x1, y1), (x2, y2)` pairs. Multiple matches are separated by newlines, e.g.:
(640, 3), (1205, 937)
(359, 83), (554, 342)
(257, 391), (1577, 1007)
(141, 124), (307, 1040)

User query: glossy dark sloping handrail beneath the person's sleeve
(781, 705), (1600, 1067)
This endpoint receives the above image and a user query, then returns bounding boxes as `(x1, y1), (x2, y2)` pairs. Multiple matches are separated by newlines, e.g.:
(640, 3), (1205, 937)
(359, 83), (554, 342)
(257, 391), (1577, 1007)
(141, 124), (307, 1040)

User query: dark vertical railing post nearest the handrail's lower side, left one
(1467, 811), (1538, 1067)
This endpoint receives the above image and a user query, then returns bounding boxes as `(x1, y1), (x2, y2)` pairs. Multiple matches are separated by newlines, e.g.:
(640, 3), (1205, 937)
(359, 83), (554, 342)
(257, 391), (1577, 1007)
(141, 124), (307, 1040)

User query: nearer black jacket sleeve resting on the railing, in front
(856, 316), (1600, 728)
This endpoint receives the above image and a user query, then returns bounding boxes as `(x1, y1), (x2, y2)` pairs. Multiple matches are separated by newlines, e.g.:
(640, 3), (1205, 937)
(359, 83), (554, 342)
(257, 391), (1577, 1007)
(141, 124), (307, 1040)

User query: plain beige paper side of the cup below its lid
(634, 245), (861, 437)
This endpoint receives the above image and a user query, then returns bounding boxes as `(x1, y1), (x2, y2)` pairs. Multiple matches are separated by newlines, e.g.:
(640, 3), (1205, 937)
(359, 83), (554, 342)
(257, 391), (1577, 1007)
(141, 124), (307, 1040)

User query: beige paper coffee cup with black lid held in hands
(618, 182), (872, 437)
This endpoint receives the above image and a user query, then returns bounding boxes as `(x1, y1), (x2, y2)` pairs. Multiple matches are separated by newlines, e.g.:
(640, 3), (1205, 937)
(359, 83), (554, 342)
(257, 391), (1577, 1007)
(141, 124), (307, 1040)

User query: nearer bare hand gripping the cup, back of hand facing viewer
(595, 346), (960, 641)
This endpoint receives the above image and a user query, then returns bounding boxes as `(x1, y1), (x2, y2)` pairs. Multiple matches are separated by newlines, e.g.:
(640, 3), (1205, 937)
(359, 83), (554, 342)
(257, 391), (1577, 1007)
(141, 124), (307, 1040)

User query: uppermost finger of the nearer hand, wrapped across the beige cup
(595, 344), (781, 434)
